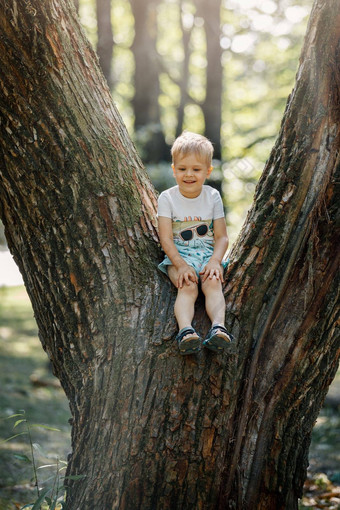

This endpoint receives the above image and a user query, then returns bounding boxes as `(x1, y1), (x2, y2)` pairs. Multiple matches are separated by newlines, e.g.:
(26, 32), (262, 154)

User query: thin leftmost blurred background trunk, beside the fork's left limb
(96, 0), (113, 90)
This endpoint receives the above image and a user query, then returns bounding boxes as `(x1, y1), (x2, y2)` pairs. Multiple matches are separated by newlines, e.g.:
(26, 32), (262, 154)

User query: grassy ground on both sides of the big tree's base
(0, 286), (340, 510)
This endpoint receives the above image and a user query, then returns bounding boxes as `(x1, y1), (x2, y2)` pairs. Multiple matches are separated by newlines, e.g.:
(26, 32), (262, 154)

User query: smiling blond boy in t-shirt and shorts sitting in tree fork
(158, 132), (232, 355)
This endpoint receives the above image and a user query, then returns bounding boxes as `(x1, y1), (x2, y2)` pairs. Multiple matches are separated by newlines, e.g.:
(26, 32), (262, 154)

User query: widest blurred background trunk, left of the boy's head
(130, 0), (169, 162)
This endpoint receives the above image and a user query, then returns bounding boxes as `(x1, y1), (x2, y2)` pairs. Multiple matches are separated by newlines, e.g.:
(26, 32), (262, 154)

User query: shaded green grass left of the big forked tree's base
(0, 287), (71, 510)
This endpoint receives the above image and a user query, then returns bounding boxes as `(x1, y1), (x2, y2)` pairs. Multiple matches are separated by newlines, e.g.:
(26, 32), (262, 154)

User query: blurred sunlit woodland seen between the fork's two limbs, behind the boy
(76, 0), (312, 240)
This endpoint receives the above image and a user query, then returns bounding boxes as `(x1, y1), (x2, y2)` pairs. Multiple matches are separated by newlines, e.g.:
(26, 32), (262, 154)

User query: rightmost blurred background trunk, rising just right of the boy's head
(195, 0), (223, 159)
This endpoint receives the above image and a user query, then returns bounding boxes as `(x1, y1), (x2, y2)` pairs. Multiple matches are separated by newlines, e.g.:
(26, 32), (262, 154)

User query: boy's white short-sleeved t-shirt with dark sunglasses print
(158, 185), (224, 246)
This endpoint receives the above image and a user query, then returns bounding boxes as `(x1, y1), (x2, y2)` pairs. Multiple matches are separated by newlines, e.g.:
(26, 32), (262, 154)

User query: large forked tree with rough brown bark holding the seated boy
(0, 0), (340, 510)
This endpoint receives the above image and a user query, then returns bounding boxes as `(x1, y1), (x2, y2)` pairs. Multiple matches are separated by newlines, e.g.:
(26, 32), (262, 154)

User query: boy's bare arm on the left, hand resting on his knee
(158, 216), (198, 288)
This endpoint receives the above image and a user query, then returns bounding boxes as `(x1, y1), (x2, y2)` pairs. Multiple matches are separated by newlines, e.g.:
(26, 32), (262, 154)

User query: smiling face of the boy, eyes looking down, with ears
(172, 154), (212, 198)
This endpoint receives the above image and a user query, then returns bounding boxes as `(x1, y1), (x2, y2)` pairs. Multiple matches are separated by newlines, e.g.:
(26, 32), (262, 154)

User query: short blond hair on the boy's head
(171, 131), (214, 167)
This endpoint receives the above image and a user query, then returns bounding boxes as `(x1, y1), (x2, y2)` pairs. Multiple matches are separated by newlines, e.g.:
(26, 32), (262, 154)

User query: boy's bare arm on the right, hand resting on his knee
(200, 218), (229, 282)
